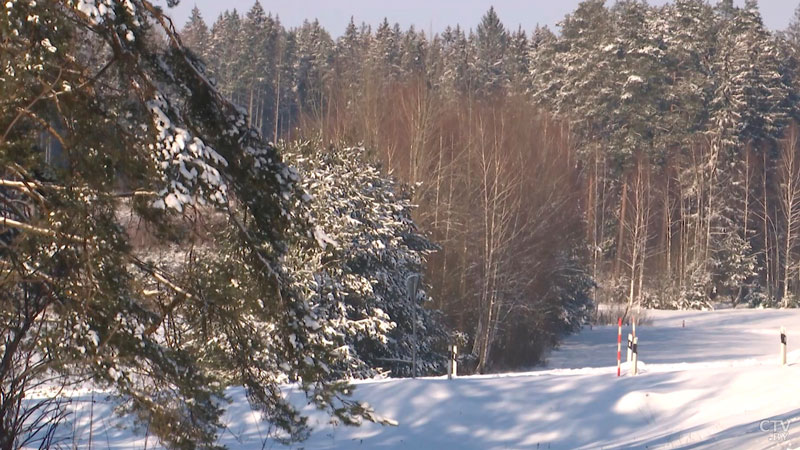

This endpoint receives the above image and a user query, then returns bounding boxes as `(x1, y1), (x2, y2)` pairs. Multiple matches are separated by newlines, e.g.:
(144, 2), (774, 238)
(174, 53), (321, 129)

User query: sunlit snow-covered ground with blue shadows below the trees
(28, 310), (800, 449)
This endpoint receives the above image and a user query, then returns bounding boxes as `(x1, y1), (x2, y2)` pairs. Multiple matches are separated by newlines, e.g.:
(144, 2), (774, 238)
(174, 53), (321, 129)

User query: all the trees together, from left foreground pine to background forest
(0, 0), (800, 450)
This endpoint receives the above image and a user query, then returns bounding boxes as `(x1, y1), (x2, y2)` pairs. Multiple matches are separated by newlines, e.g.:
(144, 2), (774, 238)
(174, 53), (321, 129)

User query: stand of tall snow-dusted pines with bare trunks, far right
(530, 0), (798, 308)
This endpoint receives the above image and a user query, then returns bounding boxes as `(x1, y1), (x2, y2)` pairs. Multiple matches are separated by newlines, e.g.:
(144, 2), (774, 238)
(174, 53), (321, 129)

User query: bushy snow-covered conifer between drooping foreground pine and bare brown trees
(286, 142), (447, 378)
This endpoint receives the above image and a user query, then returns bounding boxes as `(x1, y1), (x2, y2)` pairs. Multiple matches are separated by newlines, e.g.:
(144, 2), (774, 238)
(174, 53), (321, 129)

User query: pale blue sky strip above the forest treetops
(155, 0), (800, 36)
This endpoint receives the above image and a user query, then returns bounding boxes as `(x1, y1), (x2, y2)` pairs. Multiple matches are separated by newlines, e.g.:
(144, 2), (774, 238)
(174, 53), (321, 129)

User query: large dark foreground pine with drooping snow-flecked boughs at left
(0, 0), (388, 449)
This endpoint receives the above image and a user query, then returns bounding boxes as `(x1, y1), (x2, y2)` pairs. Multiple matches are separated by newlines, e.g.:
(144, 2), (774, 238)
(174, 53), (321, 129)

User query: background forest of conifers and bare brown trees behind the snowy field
(181, 0), (800, 370)
